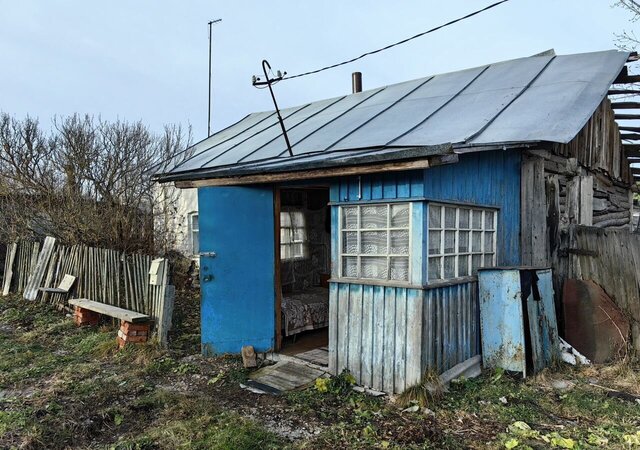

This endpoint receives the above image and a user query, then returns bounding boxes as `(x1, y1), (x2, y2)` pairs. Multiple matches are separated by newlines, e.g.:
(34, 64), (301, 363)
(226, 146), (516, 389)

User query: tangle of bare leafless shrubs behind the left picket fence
(0, 114), (191, 251)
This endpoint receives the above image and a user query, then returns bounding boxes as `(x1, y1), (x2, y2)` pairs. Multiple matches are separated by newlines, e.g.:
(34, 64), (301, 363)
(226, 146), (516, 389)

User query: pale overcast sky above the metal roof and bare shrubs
(0, 0), (634, 141)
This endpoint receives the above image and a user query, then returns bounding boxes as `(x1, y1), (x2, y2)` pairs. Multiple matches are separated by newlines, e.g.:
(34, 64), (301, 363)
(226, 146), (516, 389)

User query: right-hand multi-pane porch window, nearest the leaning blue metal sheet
(428, 203), (498, 281)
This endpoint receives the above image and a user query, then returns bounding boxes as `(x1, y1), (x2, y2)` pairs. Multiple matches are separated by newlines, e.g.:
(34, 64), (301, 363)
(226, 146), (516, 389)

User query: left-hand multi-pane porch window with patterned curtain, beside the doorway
(340, 203), (411, 282)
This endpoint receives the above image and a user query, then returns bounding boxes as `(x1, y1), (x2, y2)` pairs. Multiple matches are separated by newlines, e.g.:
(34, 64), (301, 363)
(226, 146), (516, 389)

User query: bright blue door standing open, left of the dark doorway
(198, 186), (275, 355)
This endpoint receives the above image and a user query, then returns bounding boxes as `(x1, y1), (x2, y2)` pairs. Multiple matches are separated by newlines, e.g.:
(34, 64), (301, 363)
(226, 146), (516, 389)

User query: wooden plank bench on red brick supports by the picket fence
(69, 298), (151, 348)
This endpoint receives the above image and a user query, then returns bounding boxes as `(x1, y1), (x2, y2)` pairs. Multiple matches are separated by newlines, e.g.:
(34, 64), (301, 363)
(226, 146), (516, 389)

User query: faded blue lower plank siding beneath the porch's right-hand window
(422, 281), (480, 373)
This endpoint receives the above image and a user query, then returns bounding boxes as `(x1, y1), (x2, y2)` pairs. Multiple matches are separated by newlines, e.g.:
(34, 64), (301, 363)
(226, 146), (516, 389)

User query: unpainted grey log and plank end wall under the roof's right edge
(521, 99), (633, 268)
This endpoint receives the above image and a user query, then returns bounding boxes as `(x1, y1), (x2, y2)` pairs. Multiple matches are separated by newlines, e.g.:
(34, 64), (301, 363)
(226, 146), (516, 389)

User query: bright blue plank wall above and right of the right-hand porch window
(424, 150), (521, 265)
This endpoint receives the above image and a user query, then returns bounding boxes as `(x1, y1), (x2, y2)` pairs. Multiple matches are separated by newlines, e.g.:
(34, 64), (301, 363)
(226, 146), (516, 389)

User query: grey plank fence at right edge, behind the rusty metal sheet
(553, 225), (640, 351)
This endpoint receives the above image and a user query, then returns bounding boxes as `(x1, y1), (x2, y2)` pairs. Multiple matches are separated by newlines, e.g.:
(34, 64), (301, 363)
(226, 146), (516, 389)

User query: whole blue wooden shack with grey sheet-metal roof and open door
(157, 51), (632, 392)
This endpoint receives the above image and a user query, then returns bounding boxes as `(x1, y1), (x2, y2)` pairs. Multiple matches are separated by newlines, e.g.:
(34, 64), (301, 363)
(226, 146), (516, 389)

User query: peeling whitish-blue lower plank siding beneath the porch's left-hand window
(329, 283), (424, 392)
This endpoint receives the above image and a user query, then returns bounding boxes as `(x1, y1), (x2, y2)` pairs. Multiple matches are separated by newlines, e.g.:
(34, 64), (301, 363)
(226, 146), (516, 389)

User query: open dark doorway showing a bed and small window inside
(276, 187), (331, 366)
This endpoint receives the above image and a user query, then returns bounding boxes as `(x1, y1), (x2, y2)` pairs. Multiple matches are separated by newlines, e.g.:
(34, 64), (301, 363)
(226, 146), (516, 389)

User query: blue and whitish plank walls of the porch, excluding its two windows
(329, 151), (520, 392)
